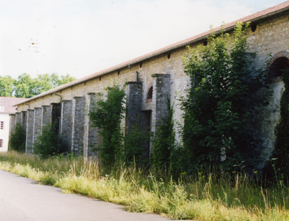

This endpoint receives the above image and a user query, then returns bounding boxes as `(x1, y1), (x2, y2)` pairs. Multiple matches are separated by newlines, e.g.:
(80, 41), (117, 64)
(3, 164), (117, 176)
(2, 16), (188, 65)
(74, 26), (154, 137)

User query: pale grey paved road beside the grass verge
(0, 170), (169, 221)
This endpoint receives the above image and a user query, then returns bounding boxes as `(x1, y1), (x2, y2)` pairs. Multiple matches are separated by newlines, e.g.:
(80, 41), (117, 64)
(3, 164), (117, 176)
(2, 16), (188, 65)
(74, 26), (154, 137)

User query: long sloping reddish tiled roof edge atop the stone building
(16, 1), (289, 105)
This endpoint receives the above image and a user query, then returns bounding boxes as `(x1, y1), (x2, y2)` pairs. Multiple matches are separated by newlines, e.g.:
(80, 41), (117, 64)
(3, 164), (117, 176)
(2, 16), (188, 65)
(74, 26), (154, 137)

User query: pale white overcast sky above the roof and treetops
(0, 0), (285, 79)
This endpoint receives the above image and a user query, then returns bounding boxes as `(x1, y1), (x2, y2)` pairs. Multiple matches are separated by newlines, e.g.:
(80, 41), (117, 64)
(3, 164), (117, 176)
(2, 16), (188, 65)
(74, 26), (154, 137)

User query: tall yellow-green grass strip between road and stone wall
(0, 152), (289, 221)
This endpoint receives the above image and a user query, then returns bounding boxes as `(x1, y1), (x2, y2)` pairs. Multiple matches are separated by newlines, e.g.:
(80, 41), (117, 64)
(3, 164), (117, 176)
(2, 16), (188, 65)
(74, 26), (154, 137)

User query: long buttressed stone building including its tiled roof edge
(10, 1), (289, 166)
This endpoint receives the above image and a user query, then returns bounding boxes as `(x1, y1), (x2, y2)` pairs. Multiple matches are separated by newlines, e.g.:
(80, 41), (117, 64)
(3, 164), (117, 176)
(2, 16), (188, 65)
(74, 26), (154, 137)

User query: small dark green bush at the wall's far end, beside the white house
(9, 123), (26, 153)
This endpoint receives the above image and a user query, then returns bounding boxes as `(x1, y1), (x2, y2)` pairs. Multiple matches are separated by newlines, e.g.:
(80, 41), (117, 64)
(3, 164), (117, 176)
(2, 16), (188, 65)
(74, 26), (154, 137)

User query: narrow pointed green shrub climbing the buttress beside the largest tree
(152, 98), (176, 168)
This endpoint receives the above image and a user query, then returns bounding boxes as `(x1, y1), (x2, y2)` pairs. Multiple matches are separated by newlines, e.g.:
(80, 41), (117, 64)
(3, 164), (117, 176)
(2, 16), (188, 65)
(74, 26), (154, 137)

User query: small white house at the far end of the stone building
(0, 97), (26, 152)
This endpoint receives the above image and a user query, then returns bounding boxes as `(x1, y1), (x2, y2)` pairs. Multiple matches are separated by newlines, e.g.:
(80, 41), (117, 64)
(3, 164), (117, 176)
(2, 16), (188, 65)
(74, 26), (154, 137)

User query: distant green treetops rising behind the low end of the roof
(0, 73), (75, 98)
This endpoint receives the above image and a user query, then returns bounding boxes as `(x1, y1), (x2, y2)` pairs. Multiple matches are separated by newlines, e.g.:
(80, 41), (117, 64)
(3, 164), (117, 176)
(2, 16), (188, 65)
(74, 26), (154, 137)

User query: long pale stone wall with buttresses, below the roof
(11, 10), (289, 167)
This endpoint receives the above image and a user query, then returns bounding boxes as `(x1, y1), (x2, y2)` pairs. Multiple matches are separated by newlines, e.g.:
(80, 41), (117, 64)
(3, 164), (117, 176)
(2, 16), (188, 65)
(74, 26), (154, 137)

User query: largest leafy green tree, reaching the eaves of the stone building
(181, 23), (268, 170)
